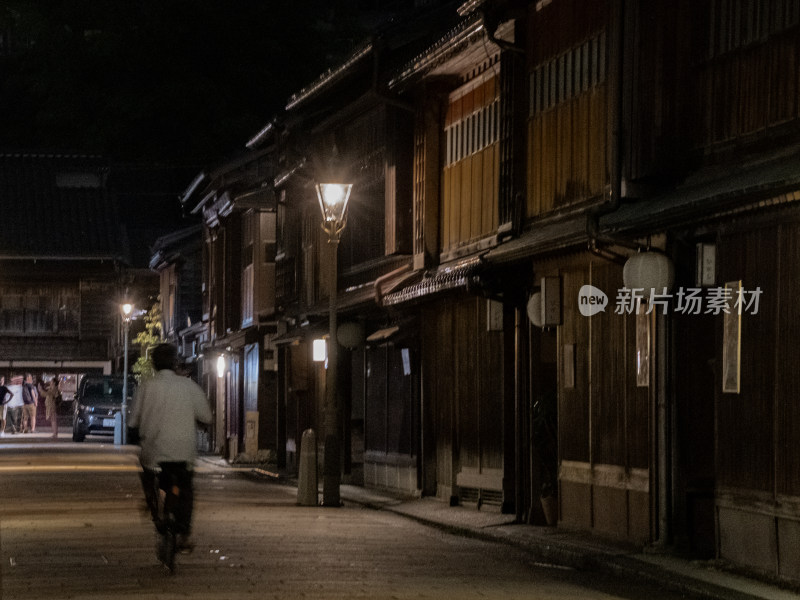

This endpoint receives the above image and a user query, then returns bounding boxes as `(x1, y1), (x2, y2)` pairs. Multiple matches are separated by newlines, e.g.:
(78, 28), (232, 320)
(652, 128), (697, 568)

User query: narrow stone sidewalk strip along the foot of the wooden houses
(198, 456), (800, 600)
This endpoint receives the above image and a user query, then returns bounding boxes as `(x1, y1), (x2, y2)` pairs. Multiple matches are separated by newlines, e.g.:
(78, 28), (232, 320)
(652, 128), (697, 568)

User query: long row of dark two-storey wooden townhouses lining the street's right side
(177, 0), (800, 579)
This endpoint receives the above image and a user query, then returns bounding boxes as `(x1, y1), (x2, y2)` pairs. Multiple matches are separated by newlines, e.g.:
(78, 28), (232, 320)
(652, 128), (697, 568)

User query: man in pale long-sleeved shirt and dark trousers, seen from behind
(129, 344), (212, 551)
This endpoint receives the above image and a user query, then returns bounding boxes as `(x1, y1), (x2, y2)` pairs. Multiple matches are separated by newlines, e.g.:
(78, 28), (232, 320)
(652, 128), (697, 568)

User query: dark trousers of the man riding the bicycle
(140, 462), (194, 535)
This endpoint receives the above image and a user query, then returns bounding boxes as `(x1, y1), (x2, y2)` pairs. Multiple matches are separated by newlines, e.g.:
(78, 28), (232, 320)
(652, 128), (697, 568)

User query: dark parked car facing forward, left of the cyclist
(72, 375), (136, 442)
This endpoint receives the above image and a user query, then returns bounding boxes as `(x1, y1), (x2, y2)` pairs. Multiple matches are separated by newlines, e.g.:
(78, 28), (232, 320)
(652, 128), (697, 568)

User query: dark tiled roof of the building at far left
(0, 154), (125, 259)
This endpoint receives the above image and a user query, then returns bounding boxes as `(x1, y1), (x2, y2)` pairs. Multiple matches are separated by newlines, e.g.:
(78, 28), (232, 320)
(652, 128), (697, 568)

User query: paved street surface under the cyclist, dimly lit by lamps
(0, 438), (700, 600)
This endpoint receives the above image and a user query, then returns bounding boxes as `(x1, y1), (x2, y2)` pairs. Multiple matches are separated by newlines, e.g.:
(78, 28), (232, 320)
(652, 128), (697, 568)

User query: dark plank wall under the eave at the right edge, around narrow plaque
(715, 214), (800, 496)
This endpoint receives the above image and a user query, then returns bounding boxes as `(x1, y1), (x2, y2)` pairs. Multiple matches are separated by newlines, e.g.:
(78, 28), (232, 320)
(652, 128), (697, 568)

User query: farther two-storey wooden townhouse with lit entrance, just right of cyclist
(180, 152), (277, 460)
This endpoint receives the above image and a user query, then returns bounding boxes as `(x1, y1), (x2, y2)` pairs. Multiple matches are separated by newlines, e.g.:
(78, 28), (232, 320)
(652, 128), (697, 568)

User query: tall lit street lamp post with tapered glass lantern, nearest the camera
(317, 183), (353, 506)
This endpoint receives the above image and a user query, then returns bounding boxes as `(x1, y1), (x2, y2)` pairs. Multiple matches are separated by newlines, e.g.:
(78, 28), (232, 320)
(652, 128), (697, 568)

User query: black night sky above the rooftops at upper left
(0, 0), (366, 165)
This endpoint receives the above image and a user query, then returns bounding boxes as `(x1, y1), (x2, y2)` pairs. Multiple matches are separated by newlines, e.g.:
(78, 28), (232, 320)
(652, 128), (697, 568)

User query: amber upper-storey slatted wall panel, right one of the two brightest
(526, 0), (609, 217)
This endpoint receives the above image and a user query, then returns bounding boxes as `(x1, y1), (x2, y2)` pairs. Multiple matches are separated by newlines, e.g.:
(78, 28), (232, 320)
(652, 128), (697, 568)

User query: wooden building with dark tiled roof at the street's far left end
(0, 153), (138, 400)
